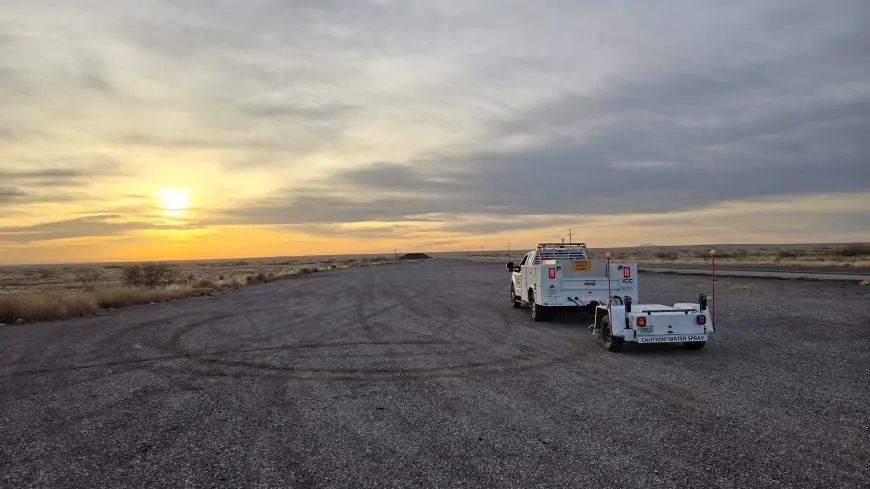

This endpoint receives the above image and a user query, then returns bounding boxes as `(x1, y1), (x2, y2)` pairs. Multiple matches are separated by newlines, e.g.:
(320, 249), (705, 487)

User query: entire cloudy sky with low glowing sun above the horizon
(0, 0), (870, 263)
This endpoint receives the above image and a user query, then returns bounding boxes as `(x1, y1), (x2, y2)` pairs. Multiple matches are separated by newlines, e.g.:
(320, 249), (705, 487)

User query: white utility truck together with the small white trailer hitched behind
(507, 243), (714, 352)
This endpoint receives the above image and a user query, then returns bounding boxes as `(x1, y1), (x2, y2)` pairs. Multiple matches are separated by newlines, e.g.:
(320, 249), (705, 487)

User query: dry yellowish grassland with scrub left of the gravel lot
(0, 252), (391, 324)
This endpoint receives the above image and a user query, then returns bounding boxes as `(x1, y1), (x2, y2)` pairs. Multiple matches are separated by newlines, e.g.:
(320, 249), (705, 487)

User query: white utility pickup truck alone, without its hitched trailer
(507, 243), (637, 321)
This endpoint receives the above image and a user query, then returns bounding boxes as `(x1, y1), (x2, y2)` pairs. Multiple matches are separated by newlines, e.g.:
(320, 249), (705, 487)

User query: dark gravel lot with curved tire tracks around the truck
(0, 260), (870, 489)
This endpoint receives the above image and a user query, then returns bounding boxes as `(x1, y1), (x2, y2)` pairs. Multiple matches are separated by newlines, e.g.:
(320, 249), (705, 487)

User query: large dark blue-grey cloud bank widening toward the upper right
(201, 2), (870, 232)
